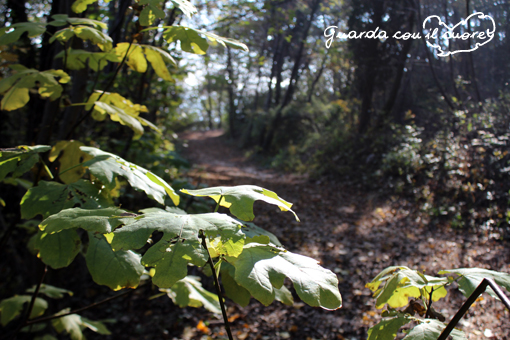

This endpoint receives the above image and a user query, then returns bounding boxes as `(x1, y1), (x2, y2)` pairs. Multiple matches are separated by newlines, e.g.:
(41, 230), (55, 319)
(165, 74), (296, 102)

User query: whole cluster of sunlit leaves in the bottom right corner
(366, 266), (510, 340)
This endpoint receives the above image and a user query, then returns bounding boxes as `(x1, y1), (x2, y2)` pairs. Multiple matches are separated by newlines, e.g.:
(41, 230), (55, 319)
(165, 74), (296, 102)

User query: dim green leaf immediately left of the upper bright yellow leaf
(55, 49), (122, 72)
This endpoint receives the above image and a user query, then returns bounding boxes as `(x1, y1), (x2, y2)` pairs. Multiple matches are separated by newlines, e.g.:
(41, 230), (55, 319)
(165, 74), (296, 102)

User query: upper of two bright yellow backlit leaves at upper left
(115, 43), (177, 81)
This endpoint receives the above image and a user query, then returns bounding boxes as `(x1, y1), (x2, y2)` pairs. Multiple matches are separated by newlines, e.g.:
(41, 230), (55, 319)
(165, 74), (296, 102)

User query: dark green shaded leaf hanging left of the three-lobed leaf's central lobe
(85, 232), (144, 290)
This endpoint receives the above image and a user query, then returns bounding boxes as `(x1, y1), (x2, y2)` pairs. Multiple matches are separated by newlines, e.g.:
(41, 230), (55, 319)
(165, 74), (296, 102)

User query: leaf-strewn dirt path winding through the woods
(176, 131), (510, 340)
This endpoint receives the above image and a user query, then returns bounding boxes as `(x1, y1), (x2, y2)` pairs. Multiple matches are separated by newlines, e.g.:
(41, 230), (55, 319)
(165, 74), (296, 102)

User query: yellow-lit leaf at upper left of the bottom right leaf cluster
(366, 266), (448, 308)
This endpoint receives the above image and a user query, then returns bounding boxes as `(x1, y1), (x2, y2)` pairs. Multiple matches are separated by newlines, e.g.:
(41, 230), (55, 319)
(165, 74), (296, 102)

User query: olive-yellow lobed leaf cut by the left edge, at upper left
(0, 68), (71, 111)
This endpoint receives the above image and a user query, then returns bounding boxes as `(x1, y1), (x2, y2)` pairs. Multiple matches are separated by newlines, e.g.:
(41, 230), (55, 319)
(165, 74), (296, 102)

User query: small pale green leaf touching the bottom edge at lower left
(51, 309), (111, 340)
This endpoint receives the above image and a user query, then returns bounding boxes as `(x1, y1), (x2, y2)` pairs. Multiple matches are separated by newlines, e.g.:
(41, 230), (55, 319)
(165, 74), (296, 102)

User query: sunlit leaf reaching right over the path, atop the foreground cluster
(181, 185), (299, 221)
